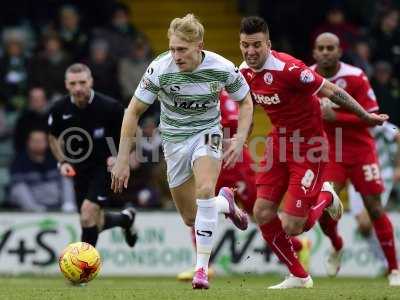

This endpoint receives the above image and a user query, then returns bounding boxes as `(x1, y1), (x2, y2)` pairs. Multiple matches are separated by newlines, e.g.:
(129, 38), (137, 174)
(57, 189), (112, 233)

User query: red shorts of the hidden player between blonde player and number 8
(215, 148), (257, 215)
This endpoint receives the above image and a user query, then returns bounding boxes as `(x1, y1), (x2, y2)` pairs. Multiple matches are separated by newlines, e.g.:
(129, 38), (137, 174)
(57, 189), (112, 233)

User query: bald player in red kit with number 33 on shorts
(311, 33), (400, 286)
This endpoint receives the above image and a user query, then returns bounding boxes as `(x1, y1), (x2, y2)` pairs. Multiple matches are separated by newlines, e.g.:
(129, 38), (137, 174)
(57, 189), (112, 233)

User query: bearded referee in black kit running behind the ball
(49, 63), (137, 247)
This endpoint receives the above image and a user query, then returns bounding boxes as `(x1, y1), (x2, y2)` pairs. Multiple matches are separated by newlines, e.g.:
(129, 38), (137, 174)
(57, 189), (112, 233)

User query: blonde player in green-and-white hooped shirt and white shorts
(111, 14), (253, 289)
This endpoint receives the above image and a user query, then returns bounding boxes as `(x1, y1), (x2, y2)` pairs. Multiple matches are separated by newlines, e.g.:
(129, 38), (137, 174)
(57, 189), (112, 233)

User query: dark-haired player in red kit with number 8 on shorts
(240, 17), (387, 289)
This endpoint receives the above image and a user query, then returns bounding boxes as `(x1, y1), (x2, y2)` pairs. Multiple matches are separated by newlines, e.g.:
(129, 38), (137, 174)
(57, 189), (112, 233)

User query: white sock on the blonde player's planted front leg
(194, 198), (218, 272)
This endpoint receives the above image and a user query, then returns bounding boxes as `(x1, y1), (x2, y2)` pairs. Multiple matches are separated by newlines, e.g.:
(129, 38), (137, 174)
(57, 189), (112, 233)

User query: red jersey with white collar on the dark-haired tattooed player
(240, 51), (324, 149)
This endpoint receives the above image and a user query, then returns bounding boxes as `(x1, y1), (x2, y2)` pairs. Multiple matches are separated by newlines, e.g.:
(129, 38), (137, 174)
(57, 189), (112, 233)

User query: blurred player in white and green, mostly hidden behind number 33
(348, 122), (400, 267)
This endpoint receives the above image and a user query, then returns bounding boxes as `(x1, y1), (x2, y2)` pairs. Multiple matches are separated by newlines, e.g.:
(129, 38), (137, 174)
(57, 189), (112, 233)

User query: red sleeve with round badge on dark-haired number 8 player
(284, 60), (325, 95)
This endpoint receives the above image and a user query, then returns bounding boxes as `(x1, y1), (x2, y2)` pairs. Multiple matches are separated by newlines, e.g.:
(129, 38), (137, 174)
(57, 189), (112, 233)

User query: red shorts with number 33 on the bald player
(324, 151), (384, 196)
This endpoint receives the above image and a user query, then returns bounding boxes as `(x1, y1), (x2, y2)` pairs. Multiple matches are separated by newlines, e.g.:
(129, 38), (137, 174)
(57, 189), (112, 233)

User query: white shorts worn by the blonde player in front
(163, 125), (222, 188)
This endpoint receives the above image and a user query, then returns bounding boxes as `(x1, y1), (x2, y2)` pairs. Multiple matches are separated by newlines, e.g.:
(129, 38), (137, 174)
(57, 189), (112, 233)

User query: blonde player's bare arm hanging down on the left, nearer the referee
(111, 96), (149, 193)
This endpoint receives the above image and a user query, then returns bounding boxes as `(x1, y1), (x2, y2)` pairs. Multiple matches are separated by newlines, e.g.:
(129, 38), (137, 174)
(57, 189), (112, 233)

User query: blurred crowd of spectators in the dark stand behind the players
(0, 0), (400, 211)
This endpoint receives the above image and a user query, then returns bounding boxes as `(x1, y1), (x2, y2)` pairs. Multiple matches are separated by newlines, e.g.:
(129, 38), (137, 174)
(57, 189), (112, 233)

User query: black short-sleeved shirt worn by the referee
(48, 91), (124, 172)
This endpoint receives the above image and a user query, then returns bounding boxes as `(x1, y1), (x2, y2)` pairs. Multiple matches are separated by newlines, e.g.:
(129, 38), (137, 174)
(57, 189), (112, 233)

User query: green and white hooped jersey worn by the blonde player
(135, 51), (249, 142)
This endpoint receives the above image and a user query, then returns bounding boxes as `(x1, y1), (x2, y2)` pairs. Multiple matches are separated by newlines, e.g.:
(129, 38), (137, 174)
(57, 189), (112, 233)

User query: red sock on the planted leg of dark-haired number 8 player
(260, 216), (308, 278)
